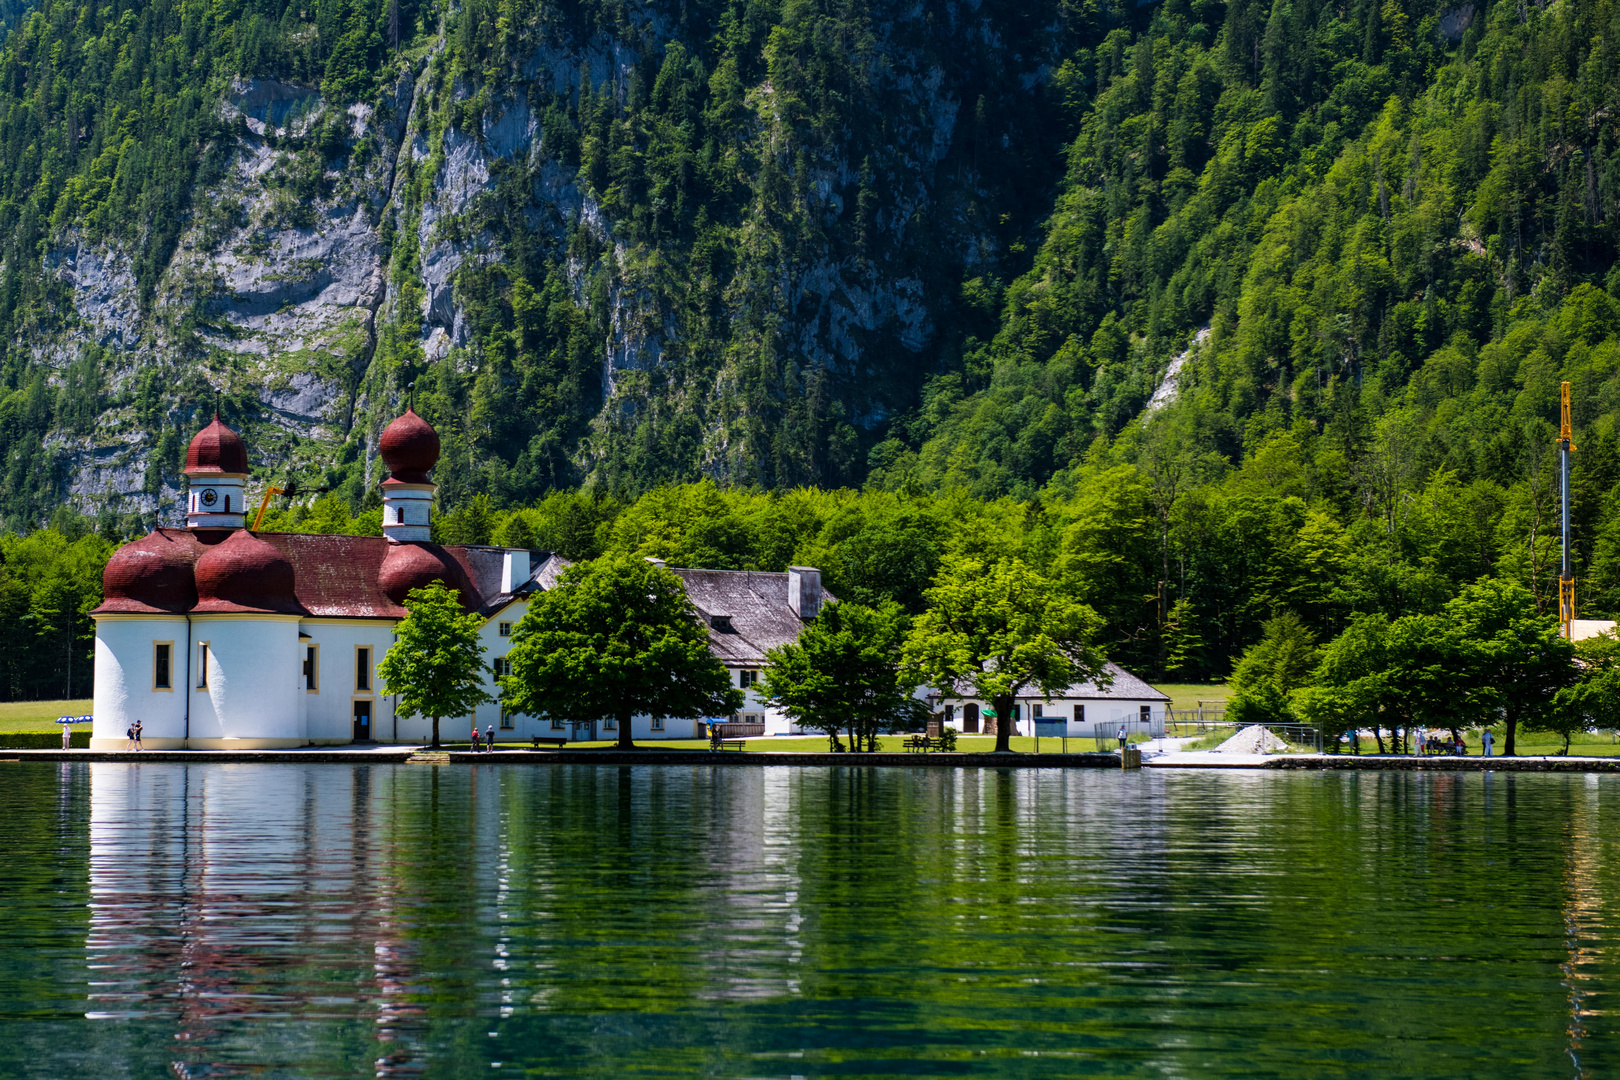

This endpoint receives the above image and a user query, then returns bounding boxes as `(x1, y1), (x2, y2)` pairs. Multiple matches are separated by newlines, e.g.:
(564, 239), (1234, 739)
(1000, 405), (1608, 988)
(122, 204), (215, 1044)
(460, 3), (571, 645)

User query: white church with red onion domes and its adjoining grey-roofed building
(91, 410), (831, 750)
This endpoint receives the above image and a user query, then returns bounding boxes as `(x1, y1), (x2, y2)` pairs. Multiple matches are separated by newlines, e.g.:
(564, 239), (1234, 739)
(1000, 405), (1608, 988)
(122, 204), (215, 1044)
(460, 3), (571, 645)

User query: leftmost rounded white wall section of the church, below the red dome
(91, 615), (186, 750)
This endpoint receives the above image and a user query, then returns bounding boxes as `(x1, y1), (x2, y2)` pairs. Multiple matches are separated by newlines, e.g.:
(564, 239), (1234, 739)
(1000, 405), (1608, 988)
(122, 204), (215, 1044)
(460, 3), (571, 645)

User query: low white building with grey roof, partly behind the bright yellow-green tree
(928, 664), (1170, 738)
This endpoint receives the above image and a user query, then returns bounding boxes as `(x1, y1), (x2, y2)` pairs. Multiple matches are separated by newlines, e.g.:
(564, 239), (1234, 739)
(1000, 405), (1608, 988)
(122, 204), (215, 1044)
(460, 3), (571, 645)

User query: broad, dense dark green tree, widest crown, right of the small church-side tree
(501, 555), (744, 750)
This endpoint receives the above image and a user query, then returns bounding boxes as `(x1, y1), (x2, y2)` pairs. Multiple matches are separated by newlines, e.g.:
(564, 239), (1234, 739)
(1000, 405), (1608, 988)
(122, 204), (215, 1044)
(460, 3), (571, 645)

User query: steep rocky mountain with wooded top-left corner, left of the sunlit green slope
(0, 0), (1085, 521)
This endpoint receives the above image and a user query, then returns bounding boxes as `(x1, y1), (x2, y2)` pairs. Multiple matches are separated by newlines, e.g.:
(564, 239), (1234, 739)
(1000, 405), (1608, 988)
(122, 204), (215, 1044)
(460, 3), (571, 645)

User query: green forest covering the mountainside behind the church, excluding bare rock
(0, 0), (1620, 709)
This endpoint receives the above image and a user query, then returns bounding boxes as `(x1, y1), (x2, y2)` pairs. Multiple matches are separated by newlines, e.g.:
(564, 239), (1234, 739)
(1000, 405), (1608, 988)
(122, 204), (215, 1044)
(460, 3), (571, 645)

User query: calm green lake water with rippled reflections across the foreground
(0, 764), (1620, 1078)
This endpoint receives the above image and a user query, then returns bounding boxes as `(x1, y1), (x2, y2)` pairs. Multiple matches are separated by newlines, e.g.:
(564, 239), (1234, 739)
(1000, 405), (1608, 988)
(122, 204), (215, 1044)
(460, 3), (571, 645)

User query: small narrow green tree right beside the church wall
(377, 581), (491, 746)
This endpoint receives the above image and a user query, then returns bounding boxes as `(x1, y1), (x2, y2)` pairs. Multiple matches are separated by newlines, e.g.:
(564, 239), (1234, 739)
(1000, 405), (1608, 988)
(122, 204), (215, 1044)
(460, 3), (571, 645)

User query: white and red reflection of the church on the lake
(86, 764), (423, 1077)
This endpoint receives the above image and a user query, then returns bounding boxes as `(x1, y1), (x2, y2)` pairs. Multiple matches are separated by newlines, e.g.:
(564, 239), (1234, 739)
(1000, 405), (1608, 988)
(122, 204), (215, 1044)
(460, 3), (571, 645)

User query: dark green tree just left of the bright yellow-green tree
(761, 602), (915, 751)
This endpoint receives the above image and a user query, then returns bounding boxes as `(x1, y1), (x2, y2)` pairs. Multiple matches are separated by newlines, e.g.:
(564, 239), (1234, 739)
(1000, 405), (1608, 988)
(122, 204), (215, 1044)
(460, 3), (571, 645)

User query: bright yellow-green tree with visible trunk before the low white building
(904, 559), (1106, 753)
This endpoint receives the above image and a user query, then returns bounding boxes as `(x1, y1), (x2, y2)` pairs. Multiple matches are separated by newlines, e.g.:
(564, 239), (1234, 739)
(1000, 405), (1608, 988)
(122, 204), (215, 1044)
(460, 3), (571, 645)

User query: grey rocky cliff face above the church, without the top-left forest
(23, 3), (1063, 520)
